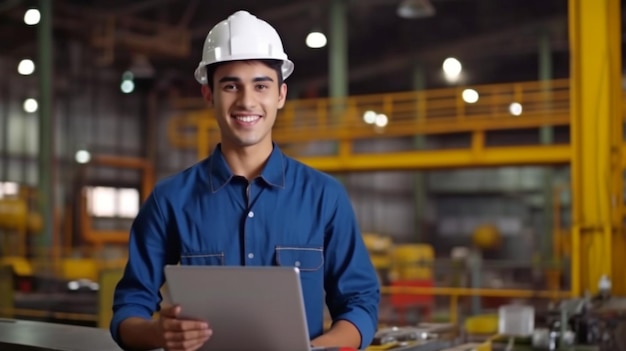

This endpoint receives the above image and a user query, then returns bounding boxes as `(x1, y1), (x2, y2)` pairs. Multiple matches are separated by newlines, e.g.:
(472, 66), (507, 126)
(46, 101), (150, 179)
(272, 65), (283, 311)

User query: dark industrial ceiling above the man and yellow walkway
(0, 0), (616, 97)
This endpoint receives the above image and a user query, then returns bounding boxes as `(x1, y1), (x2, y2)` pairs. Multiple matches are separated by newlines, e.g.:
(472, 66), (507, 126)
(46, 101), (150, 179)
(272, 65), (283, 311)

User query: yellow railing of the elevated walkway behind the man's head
(168, 79), (570, 157)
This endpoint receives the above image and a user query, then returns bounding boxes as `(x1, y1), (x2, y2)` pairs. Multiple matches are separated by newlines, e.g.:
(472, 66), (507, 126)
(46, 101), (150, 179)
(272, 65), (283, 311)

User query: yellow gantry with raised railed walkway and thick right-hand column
(168, 0), (626, 296)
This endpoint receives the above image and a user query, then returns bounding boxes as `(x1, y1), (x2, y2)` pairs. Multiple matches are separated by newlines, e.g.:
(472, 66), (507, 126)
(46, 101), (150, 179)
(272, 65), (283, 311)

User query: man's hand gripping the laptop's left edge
(159, 306), (213, 351)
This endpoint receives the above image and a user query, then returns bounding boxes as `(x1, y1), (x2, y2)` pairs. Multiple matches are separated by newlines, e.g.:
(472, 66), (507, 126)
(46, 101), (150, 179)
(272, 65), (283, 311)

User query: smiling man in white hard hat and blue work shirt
(111, 11), (380, 350)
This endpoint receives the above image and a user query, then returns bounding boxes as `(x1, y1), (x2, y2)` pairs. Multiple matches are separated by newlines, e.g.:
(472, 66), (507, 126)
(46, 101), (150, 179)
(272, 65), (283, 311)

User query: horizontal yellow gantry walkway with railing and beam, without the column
(168, 80), (571, 172)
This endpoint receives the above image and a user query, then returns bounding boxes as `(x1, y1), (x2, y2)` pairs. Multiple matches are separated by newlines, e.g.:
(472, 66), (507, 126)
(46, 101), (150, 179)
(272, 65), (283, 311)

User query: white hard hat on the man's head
(195, 11), (294, 84)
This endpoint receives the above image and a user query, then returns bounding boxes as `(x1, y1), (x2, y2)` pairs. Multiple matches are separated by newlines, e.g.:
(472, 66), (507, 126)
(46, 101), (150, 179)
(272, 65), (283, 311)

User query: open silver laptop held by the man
(165, 265), (317, 351)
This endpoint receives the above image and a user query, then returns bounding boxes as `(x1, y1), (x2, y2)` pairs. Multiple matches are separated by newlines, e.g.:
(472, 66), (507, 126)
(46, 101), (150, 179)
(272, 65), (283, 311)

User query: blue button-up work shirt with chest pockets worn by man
(110, 145), (380, 347)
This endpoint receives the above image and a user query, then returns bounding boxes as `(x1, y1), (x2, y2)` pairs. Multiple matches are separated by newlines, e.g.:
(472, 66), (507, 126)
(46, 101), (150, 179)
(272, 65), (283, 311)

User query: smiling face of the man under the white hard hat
(202, 61), (287, 148)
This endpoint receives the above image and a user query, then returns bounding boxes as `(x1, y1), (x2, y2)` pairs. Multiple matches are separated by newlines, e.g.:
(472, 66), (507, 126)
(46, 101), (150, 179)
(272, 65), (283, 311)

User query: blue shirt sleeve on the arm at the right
(325, 187), (380, 348)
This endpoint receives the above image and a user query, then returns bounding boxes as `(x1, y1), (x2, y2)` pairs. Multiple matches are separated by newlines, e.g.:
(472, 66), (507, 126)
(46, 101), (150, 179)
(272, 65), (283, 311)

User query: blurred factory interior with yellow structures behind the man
(0, 0), (626, 351)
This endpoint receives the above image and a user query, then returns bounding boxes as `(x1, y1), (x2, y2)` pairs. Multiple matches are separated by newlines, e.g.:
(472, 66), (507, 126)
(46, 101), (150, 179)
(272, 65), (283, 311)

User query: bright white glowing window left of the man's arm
(86, 186), (140, 218)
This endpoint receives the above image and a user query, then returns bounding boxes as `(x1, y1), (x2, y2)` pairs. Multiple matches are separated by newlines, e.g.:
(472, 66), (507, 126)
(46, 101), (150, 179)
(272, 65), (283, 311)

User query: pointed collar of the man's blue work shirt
(209, 143), (285, 192)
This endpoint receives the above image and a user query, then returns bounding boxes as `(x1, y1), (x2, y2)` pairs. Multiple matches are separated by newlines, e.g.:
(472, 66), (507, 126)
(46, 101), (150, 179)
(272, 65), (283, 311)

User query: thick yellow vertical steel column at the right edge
(569, 0), (626, 295)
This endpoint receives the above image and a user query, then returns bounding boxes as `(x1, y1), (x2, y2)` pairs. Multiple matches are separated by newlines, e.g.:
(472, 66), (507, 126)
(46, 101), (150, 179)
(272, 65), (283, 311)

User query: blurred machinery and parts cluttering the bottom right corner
(358, 295), (626, 351)
